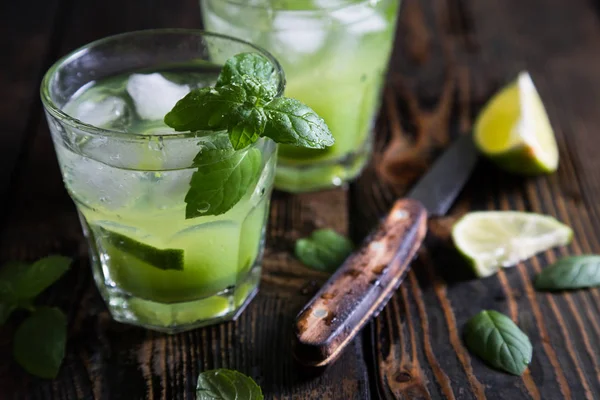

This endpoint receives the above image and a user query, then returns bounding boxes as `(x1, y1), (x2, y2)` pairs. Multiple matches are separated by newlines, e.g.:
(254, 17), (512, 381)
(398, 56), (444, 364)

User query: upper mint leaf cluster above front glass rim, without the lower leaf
(165, 53), (333, 150)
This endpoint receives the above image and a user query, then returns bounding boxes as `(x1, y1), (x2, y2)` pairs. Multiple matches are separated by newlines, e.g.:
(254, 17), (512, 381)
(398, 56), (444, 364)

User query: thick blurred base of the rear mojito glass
(275, 138), (373, 193)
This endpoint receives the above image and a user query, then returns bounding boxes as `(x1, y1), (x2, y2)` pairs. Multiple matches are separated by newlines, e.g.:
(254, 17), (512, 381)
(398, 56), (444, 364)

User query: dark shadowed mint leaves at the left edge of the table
(0, 256), (72, 379)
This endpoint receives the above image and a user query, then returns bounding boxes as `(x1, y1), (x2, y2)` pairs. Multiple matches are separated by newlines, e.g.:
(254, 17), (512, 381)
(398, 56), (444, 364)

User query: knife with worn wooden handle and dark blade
(294, 135), (478, 366)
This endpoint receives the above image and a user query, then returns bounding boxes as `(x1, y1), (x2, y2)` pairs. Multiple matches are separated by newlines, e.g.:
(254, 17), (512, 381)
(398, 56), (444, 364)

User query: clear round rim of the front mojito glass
(40, 28), (286, 141)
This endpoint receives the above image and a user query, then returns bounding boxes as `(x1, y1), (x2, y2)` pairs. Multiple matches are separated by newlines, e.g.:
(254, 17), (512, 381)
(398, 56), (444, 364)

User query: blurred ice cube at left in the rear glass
(273, 12), (327, 57)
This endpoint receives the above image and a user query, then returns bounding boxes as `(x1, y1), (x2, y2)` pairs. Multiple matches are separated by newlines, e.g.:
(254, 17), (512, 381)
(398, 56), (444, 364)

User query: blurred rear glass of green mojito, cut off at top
(201, 0), (399, 192)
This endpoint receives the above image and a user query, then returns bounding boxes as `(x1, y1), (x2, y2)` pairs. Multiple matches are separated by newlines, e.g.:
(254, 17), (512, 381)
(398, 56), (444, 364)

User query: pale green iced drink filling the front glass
(53, 67), (275, 306)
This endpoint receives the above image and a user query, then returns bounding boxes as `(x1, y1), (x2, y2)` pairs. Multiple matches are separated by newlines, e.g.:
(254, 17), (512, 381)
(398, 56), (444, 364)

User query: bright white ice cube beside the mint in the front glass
(127, 72), (190, 120)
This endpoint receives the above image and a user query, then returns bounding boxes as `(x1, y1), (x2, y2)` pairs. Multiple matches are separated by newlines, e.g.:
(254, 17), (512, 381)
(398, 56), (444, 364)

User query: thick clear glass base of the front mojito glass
(96, 264), (261, 334)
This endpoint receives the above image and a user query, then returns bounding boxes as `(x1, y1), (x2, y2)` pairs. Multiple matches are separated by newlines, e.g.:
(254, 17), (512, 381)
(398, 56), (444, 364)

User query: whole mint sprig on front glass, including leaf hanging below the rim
(164, 53), (333, 218)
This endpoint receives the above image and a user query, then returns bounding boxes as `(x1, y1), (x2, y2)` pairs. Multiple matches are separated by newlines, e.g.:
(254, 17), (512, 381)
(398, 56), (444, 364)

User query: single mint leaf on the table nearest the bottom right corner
(465, 310), (533, 375)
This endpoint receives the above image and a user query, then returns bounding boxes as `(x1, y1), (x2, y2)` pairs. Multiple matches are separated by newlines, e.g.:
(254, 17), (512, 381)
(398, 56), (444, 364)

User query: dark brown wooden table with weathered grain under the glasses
(0, 0), (600, 400)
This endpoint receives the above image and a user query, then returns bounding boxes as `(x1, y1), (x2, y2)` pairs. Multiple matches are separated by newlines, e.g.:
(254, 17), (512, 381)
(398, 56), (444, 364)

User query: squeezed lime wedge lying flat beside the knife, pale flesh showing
(452, 211), (573, 277)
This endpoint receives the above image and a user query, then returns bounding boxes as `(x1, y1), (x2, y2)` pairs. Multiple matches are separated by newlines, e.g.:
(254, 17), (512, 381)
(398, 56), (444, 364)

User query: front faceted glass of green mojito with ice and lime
(41, 30), (285, 333)
